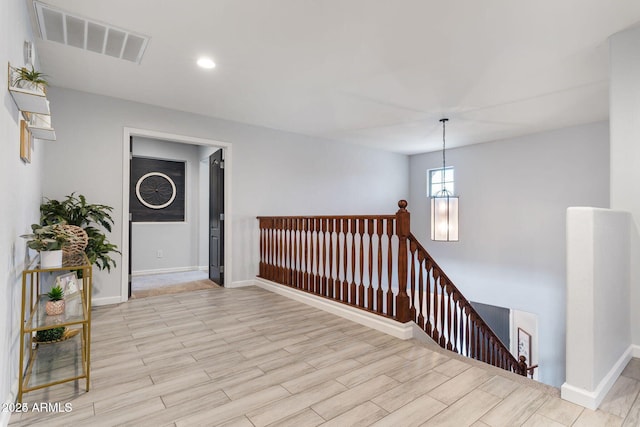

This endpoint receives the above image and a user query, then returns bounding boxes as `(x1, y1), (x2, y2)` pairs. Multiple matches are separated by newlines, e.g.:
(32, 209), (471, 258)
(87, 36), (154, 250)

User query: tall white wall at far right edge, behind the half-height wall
(609, 27), (640, 345)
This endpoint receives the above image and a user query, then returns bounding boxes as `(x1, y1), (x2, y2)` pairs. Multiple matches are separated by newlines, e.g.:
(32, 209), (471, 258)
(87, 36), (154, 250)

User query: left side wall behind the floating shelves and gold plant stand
(0, 0), (43, 425)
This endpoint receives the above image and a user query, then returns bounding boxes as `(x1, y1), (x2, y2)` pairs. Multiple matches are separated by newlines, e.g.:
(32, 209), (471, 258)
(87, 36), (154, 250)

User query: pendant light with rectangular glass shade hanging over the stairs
(431, 119), (458, 242)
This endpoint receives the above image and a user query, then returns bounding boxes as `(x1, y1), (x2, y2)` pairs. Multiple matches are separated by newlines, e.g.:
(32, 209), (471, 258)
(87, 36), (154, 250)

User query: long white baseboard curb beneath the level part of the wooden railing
(251, 278), (414, 340)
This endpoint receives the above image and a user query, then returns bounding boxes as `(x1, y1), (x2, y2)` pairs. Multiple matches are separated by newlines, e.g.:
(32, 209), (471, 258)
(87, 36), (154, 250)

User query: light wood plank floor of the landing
(10, 287), (640, 427)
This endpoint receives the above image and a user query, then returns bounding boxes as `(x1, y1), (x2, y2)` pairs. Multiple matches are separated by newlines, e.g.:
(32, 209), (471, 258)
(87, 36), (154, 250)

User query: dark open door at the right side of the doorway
(209, 149), (224, 286)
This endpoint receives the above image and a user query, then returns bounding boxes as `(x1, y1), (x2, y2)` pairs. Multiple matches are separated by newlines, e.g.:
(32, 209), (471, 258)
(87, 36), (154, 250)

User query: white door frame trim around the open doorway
(120, 127), (233, 302)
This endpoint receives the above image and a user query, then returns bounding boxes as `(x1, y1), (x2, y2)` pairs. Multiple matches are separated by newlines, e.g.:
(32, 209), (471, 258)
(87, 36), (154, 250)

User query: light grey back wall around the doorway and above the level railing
(44, 88), (408, 302)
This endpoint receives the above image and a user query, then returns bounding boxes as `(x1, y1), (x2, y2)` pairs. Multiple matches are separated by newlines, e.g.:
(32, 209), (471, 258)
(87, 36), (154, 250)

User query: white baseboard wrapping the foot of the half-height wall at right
(560, 345), (640, 411)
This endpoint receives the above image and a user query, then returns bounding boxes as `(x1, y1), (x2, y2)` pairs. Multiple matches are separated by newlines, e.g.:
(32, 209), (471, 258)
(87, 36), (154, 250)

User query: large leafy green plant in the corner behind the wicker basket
(40, 193), (120, 271)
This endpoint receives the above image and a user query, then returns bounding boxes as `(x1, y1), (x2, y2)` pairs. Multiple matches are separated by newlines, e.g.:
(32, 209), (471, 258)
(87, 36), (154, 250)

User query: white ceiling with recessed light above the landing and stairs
(31, 0), (640, 154)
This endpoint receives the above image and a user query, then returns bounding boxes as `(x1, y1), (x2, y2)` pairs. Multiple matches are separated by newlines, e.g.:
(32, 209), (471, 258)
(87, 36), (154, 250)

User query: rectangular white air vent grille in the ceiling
(33, 1), (149, 64)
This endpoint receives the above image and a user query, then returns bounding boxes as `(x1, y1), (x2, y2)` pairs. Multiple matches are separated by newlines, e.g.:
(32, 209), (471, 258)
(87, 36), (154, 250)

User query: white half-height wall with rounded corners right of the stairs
(562, 207), (631, 409)
